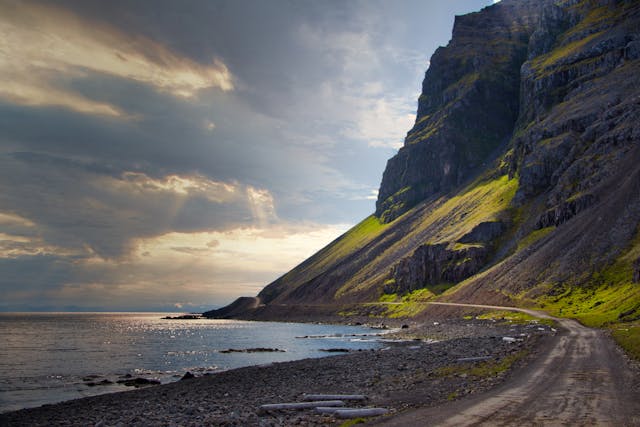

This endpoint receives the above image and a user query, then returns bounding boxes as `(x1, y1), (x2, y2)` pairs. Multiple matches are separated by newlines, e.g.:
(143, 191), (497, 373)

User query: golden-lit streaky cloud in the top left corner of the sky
(0, 0), (234, 117)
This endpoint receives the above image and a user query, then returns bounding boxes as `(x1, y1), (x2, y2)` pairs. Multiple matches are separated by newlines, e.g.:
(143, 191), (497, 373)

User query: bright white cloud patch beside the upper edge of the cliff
(298, 19), (426, 149)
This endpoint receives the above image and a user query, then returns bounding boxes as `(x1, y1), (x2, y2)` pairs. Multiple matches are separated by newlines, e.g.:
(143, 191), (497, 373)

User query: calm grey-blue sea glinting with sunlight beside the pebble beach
(0, 313), (380, 412)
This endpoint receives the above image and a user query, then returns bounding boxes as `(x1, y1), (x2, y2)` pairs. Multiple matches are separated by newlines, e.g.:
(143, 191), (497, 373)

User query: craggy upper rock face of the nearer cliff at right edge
(512, 0), (640, 217)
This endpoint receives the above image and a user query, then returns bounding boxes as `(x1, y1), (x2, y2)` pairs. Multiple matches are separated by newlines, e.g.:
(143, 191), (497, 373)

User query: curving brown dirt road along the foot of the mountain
(375, 303), (640, 427)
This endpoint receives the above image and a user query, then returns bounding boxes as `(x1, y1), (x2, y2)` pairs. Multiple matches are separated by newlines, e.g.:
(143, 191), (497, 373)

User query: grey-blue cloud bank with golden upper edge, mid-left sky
(0, 153), (276, 258)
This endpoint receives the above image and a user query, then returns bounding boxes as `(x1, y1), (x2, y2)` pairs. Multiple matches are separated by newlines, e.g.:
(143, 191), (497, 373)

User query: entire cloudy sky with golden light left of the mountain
(0, 0), (493, 312)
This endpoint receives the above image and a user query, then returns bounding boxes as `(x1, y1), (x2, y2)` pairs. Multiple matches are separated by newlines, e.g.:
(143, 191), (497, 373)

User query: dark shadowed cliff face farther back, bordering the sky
(376, 0), (549, 222)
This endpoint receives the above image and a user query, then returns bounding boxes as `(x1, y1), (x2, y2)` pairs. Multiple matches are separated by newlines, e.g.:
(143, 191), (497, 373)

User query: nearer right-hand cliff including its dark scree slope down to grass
(456, 1), (640, 316)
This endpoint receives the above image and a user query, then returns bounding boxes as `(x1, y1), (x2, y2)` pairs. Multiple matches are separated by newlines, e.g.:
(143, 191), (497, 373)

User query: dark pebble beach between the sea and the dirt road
(0, 319), (554, 426)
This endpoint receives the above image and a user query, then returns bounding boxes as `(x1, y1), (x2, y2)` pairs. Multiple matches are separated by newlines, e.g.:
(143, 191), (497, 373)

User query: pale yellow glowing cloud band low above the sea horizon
(0, 223), (348, 310)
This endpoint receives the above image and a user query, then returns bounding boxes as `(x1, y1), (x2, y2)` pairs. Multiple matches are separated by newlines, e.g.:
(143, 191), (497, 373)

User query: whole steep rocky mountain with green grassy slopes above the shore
(206, 0), (640, 332)
